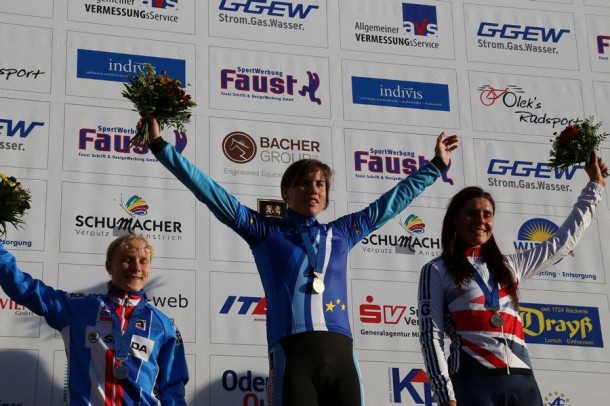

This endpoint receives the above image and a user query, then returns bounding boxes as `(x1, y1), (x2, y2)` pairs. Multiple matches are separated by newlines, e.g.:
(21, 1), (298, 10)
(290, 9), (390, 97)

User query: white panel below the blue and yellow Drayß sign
(535, 369), (610, 406)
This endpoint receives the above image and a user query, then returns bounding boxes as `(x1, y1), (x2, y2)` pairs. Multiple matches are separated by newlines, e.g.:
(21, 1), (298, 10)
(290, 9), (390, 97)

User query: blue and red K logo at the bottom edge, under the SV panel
(388, 368), (436, 406)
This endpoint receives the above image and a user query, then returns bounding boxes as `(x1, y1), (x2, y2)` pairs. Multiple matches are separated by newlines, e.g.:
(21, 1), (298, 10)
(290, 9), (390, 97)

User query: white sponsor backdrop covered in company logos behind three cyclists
(0, 0), (610, 406)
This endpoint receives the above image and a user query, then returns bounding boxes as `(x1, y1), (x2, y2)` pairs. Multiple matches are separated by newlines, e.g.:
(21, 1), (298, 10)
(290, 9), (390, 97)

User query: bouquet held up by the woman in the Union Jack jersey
(550, 117), (608, 177)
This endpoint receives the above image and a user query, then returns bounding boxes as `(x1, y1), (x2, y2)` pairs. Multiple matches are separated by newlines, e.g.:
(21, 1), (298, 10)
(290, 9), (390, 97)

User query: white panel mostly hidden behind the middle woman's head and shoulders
(210, 194), (336, 262)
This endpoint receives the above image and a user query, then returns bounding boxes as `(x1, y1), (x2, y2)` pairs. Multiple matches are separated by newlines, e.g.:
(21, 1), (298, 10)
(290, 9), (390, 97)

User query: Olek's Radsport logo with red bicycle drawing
(477, 84), (581, 128)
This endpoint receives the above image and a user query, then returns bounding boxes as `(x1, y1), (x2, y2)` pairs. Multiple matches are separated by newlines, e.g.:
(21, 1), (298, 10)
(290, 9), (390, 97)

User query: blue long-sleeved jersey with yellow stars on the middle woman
(151, 139), (444, 347)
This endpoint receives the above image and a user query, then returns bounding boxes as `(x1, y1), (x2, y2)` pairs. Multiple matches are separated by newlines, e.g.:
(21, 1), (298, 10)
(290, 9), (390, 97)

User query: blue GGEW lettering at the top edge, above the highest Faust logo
(218, 0), (320, 20)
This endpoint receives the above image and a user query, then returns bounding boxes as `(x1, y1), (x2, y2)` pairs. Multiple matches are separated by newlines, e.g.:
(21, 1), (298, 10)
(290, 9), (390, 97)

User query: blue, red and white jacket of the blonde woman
(0, 244), (188, 406)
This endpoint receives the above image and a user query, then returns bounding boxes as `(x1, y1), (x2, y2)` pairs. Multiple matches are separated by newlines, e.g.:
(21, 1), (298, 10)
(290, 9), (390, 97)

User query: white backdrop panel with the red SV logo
(351, 280), (421, 353)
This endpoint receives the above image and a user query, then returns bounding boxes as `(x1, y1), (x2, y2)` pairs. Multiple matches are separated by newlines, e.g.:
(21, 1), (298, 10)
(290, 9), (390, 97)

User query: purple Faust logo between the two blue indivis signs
(220, 66), (322, 105)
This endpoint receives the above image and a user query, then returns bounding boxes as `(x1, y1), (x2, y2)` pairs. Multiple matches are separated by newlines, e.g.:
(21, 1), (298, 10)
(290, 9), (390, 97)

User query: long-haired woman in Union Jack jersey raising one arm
(418, 154), (607, 406)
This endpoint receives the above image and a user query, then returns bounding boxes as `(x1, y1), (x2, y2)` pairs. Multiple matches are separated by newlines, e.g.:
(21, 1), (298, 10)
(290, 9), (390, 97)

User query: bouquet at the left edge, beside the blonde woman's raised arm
(0, 173), (31, 236)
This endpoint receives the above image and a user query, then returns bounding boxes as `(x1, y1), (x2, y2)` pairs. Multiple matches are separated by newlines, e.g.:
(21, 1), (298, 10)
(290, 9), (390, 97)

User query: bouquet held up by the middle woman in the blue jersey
(122, 63), (197, 146)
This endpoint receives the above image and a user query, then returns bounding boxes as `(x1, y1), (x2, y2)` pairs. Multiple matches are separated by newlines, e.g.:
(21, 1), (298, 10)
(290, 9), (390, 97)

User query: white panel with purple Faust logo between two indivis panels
(209, 47), (330, 118)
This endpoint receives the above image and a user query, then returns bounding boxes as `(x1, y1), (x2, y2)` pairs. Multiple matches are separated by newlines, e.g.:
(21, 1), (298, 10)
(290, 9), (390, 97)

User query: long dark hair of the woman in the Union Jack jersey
(441, 186), (519, 306)
